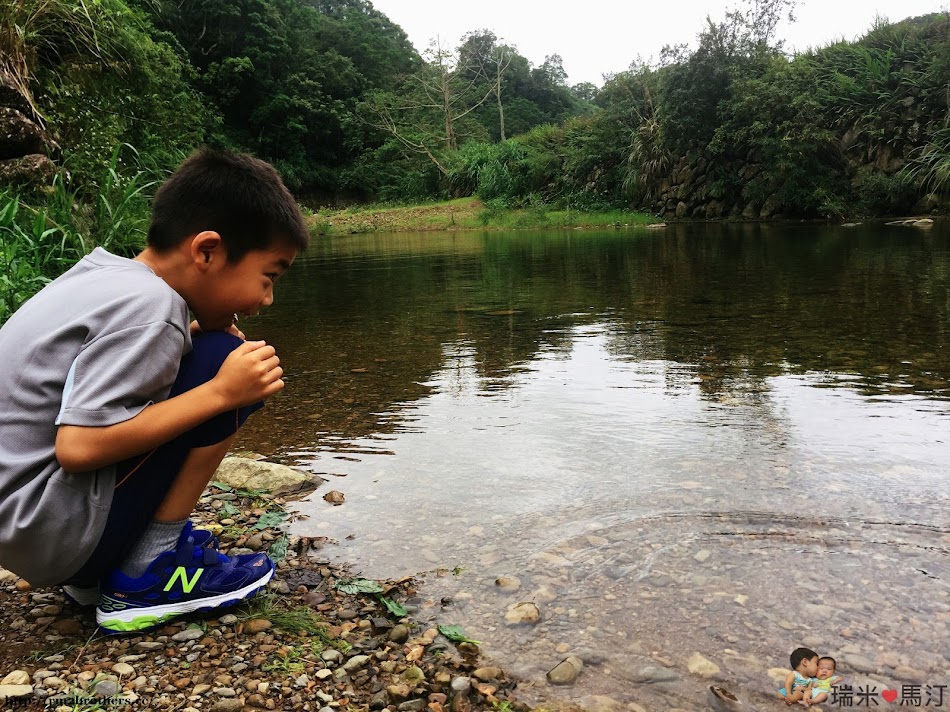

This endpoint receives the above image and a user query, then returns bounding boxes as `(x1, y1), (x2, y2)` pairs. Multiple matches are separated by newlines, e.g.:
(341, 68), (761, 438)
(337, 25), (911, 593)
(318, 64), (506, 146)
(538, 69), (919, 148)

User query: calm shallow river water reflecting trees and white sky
(241, 221), (950, 710)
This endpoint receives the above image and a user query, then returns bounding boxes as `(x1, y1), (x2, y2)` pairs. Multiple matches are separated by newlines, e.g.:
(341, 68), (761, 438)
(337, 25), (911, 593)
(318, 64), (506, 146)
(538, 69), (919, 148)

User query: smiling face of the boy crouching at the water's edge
(189, 240), (297, 331)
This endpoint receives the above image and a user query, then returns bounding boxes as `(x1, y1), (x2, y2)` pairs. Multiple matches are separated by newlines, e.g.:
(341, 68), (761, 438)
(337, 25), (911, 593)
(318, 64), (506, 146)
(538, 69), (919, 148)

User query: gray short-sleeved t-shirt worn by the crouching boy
(0, 248), (191, 586)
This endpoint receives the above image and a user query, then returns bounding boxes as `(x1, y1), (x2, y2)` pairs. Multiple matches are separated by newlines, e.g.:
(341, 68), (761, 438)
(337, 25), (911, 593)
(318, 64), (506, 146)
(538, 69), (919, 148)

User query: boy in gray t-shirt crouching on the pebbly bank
(0, 150), (308, 632)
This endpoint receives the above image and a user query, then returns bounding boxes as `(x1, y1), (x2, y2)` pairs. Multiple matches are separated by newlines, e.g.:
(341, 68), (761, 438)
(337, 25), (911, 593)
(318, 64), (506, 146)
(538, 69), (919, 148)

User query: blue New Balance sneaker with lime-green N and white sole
(96, 522), (274, 633)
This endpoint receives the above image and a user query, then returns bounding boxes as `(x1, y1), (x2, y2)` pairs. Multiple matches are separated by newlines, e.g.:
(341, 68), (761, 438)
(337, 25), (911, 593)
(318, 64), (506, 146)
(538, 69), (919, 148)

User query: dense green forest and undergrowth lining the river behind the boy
(0, 0), (950, 321)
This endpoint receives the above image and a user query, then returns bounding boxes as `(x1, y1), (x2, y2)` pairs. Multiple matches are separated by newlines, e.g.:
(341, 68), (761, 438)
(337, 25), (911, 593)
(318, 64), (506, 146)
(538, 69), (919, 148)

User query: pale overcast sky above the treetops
(372, 0), (948, 86)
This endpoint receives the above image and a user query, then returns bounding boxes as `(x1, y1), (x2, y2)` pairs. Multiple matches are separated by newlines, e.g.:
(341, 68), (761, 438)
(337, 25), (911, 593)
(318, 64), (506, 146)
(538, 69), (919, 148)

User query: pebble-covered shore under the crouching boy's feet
(0, 458), (527, 712)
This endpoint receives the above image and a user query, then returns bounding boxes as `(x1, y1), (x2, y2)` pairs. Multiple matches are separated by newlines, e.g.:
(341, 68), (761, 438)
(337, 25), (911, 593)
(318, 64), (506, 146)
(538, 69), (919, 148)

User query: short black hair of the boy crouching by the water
(148, 148), (310, 263)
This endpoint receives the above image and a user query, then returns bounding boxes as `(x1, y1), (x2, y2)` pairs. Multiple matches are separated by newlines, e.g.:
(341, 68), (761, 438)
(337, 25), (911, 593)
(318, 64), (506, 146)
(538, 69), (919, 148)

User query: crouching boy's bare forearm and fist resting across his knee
(56, 341), (284, 472)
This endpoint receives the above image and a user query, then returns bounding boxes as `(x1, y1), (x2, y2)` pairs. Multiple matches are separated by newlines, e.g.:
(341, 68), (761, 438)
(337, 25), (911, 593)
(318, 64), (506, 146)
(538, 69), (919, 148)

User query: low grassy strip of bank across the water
(308, 198), (655, 235)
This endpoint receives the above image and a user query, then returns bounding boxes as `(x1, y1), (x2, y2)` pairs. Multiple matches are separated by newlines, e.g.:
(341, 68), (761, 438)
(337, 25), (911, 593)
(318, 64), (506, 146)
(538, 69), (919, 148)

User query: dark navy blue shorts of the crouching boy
(64, 331), (264, 586)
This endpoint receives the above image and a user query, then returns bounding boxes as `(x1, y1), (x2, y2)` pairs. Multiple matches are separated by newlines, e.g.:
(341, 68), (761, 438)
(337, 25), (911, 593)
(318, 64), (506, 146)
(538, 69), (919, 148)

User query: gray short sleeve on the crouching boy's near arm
(56, 321), (185, 426)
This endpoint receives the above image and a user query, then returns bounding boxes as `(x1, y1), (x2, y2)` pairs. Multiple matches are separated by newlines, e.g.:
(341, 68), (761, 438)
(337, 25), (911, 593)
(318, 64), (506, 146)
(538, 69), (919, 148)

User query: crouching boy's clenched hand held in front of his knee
(210, 341), (284, 410)
